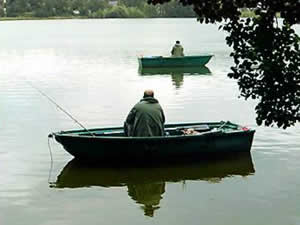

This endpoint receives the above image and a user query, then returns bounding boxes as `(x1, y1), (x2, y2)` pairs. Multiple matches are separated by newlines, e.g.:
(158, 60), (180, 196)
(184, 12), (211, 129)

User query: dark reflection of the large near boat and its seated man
(51, 153), (255, 217)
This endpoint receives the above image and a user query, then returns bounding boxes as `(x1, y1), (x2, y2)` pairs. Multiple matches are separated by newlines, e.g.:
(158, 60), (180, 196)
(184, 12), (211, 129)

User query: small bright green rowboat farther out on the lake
(138, 55), (213, 67)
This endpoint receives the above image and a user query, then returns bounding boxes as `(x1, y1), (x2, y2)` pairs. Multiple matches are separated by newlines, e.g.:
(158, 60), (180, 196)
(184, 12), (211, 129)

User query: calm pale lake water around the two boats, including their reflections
(0, 19), (300, 225)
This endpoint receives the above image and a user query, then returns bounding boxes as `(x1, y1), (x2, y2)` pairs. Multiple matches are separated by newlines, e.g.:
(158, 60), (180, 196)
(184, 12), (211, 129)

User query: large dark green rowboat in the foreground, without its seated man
(50, 121), (255, 162)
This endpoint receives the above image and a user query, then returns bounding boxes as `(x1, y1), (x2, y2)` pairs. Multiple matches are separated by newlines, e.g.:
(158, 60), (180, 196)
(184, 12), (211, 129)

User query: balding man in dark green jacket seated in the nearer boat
(124, 90), (165, 137)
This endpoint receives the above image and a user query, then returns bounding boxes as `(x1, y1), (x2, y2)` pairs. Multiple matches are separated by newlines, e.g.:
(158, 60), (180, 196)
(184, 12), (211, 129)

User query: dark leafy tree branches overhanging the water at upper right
(148, 0), (300, 128)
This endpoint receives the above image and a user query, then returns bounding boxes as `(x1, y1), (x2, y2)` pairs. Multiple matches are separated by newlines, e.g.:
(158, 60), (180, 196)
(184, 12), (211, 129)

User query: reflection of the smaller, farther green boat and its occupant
(139, 66), (211, 88)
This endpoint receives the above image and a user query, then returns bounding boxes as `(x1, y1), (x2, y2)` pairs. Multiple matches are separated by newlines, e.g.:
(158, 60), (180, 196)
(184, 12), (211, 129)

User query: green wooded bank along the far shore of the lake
(0, 0), (195, 18)
